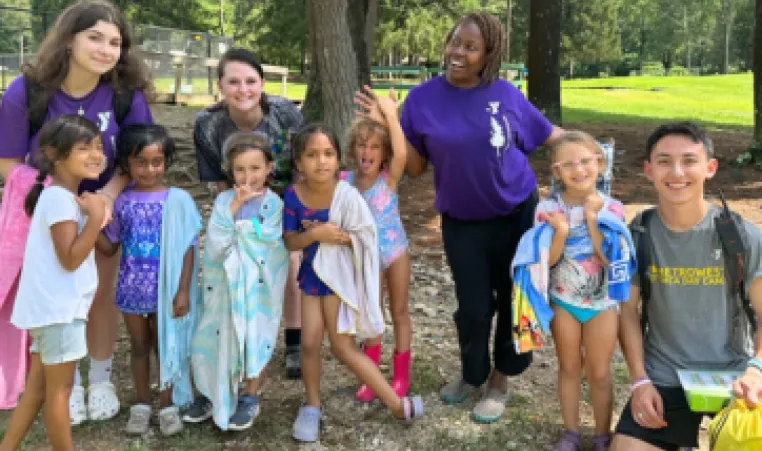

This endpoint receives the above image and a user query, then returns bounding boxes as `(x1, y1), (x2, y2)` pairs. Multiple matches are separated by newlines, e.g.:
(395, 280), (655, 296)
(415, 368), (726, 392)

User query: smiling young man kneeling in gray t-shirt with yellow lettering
(611, 123), (762, 451)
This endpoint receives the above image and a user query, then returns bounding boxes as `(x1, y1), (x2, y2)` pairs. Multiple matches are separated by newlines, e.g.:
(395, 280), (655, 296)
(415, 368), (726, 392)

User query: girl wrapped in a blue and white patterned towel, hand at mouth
(188, 132), (288, 431)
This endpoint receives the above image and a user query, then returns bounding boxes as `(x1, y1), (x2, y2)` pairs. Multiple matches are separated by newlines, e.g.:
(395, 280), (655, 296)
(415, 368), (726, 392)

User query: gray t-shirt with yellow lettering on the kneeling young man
(633, 205), (762, 386)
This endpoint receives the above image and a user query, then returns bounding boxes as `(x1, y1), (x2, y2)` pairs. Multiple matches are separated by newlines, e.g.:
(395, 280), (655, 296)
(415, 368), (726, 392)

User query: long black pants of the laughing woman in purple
(442, 192), (538, 386)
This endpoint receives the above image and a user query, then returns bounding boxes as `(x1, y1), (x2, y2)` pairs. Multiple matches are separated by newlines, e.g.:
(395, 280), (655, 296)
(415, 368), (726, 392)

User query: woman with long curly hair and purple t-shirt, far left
(0, 1), (152, 423)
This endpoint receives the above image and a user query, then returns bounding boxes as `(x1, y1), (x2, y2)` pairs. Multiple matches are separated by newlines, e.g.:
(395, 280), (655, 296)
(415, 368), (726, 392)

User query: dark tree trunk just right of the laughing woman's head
(527, 0), (561, 123)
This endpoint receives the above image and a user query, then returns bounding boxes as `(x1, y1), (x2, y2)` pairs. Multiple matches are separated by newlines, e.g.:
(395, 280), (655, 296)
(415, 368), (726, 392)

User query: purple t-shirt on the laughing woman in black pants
(401, 76), (553, 220)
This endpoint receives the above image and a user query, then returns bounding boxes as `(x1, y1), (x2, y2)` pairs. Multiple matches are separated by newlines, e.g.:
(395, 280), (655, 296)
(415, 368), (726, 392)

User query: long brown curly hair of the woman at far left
(23, 0), (152, 120)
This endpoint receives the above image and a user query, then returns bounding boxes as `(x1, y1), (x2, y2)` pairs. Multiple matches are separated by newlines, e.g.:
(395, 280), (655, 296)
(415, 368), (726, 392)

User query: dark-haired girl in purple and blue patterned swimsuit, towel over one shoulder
(98, 125), (199, 436)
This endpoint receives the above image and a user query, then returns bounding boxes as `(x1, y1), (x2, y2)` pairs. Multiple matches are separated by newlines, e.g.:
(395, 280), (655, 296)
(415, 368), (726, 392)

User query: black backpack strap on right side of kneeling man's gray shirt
(714, 191), (756, 326)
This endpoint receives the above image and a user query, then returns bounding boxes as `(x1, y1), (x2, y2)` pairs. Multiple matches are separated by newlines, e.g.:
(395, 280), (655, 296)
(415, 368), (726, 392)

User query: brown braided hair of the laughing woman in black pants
(445, 12), (505, 85)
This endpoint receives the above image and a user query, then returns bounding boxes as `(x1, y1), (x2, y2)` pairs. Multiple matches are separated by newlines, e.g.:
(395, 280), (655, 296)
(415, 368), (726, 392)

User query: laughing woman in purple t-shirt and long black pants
(356, 13), (560, 423)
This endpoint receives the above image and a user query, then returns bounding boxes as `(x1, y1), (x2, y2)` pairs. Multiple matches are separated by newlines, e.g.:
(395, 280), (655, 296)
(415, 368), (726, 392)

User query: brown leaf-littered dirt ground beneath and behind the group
(0, 106), (762, 451)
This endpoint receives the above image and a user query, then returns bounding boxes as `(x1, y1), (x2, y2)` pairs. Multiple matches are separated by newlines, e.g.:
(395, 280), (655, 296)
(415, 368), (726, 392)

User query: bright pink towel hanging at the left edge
(0, 164), (50, 409)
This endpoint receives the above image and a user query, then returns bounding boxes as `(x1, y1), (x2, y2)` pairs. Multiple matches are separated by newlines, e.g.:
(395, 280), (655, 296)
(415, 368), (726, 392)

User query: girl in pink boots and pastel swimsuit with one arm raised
(342, 90), (413, 402)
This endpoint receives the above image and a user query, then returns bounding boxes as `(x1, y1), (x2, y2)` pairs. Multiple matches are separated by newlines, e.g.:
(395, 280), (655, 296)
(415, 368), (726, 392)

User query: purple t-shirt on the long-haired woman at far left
(0, 76), (153, 191)
